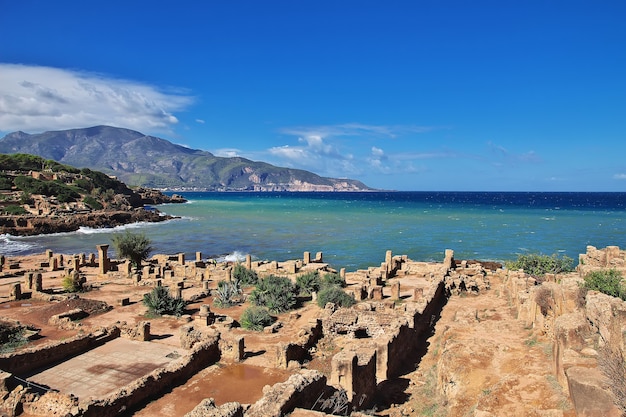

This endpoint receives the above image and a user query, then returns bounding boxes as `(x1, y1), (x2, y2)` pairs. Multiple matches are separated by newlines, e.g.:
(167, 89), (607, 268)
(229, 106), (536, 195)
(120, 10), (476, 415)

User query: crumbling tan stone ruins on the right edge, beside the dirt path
(499, 246), (626, 417)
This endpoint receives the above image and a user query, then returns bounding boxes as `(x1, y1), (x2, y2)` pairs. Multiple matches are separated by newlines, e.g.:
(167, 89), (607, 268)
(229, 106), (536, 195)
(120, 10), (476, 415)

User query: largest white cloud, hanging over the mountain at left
(0, 64), (193, 132)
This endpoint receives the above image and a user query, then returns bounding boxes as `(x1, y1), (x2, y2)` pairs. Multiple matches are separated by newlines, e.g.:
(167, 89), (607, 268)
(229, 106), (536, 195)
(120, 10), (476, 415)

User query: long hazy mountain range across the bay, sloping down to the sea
(0, 126), (371, 191)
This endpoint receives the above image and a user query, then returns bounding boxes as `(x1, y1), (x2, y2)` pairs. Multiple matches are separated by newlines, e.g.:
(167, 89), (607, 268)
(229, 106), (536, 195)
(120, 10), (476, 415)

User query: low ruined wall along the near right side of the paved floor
(76, 336), (220, 417)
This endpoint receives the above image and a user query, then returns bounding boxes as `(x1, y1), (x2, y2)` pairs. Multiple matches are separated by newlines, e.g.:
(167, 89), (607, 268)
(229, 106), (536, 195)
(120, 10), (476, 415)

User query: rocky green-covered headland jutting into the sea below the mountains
(0, 155), (186, 236)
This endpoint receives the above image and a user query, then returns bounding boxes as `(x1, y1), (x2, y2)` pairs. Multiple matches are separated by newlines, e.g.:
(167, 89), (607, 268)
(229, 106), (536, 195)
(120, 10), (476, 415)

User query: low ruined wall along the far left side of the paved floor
(0, 327), (120, 376)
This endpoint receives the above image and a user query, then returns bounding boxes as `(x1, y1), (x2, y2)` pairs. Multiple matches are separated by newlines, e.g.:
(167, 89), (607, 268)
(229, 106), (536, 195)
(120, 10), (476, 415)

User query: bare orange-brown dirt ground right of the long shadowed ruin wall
(378, 272), (576, 417)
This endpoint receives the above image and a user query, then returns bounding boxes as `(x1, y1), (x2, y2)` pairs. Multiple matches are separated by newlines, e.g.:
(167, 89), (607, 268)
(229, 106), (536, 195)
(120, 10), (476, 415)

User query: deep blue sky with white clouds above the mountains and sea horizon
(0, 0), (626, 191)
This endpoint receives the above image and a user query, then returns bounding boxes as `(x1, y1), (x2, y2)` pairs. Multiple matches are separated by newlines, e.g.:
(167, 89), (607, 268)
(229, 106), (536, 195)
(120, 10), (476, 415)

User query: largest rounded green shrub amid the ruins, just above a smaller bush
(250, 275), (297, 313)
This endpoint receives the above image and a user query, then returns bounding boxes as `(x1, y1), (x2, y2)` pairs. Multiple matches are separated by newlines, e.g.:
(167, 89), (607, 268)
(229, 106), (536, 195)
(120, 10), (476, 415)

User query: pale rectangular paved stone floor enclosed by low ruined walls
(28, 337), (187, 400)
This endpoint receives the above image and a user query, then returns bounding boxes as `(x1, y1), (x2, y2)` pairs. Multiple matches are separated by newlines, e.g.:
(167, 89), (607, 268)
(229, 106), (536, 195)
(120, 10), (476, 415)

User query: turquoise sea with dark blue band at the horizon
(0, 192), (626, 271)
